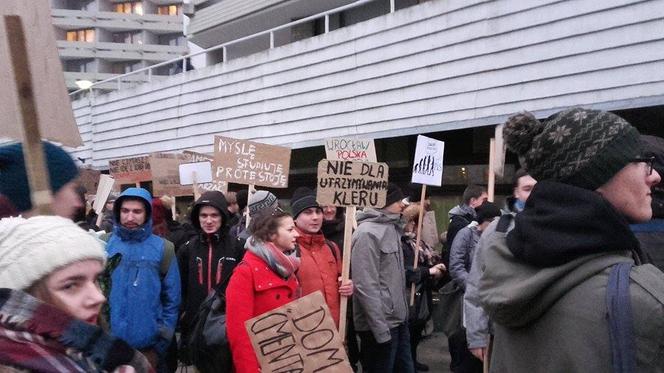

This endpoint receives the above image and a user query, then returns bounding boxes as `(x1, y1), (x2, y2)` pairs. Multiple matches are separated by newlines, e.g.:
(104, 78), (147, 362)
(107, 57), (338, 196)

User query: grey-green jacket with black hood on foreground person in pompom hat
(479, 181), (664, 372)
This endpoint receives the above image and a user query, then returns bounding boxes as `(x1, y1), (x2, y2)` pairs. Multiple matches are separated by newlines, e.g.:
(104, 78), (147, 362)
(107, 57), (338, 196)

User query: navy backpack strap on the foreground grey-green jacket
(606, 262), (636, 373)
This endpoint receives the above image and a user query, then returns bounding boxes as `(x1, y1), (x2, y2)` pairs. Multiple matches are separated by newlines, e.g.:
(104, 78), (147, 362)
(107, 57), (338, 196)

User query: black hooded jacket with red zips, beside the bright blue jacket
(178, 192), (244, 333)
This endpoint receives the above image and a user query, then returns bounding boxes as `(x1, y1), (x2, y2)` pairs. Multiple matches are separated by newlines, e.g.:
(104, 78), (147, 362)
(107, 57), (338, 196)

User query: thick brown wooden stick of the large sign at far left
(4, 16), (53, 215)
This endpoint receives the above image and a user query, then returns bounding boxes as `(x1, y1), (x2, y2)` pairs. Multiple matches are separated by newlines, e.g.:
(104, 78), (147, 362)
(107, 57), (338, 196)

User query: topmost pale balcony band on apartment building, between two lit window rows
(51, 9), (184, 33)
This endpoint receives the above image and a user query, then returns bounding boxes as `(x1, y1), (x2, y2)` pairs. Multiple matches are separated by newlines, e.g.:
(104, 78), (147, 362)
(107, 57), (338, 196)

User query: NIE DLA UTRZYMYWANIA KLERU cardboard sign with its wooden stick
(316, 159), (389, 339)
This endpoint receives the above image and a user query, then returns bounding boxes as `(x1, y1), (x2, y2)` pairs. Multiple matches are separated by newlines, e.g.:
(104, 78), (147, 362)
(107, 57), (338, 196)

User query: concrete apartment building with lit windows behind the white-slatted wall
(51, 0), (188, 90)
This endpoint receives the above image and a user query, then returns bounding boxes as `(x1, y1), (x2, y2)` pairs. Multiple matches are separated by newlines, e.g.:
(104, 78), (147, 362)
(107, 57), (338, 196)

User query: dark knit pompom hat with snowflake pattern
(503, 107), (641, 190)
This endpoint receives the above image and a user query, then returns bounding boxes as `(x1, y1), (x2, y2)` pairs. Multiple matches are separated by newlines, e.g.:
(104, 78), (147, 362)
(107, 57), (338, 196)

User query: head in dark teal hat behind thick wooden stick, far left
(0, 141), (85, 219)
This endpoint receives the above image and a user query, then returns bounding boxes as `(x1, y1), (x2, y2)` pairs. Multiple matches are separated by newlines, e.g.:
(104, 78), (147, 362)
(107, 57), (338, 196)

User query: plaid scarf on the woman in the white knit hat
(0, 289), (153, 372)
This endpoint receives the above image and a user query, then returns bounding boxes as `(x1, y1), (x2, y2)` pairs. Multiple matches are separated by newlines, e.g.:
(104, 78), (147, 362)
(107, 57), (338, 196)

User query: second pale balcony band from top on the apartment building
(57, 40), (188, 62)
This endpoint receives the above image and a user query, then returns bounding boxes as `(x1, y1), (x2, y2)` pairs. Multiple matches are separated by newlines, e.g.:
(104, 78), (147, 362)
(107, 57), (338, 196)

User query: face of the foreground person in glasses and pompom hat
(597, 158), (661, 223)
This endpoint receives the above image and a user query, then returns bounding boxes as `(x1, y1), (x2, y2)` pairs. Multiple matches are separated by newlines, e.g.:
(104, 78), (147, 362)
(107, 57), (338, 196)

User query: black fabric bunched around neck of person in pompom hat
(507, 181), (647, 267)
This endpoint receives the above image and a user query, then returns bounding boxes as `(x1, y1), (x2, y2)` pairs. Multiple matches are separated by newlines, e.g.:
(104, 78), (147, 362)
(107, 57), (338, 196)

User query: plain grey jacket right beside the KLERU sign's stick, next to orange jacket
(351, 208), (408, 343)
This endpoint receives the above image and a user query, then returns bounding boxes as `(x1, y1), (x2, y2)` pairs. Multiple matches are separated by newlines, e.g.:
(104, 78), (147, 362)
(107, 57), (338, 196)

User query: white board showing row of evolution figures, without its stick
(411, 135), (445, 186)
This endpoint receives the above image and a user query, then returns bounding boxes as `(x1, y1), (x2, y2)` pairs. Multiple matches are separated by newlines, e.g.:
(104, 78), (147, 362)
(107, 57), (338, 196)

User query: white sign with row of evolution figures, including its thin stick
(410, 135), (445, 306)
